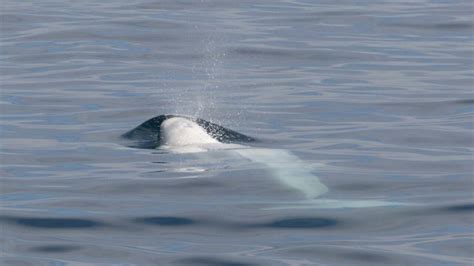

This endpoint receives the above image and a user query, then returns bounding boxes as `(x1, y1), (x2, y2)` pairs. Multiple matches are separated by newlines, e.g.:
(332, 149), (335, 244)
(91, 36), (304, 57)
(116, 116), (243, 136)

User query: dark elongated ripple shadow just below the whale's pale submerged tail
(262, 217), (340, 228)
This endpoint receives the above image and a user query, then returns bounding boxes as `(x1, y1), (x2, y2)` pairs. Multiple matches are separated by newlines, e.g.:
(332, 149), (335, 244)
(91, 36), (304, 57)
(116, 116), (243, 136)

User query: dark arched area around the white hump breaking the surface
(122, 115), (256, 149)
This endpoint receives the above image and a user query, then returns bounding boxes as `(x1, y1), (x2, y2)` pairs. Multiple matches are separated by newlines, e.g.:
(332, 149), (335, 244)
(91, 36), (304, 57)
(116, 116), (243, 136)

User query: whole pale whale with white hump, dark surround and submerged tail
(123, 115), (399, 209)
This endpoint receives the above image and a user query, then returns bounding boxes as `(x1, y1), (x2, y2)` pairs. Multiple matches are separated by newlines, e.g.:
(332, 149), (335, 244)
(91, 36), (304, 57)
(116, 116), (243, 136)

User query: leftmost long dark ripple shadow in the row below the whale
(0, 216), (104, 229)
